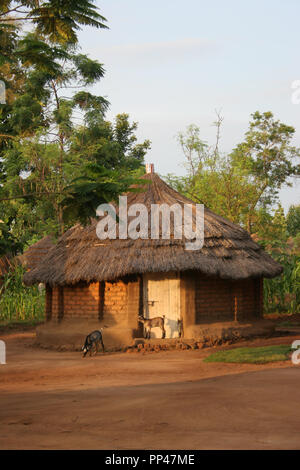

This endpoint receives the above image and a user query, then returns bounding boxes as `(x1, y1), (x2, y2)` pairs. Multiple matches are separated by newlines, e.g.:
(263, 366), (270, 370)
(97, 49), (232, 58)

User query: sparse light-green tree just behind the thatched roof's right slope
(168, 114), (252, 223)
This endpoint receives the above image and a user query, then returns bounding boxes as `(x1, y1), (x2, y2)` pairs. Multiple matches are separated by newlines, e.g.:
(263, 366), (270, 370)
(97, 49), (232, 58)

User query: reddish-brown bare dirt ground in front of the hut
(0, 331), (300, 450)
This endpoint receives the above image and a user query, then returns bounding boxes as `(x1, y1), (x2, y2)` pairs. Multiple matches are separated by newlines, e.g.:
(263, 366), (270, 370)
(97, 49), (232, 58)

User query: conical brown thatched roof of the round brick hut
(24, 173), (282, 285)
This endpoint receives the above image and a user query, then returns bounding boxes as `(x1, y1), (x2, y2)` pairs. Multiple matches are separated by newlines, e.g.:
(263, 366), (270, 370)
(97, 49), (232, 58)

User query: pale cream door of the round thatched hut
(143, 273), (180, 338)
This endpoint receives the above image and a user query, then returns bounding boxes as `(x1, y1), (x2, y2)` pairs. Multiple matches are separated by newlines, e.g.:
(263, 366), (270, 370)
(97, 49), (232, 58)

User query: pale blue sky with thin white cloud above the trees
(79, 0), (300, 211)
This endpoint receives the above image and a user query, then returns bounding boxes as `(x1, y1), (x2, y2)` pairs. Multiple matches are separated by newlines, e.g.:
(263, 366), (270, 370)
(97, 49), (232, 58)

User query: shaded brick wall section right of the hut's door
(195, 276), (262, 323)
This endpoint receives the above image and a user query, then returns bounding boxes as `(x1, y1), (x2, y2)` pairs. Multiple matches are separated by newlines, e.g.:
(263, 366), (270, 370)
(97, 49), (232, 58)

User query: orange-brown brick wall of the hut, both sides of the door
(46, 273), (262, 328)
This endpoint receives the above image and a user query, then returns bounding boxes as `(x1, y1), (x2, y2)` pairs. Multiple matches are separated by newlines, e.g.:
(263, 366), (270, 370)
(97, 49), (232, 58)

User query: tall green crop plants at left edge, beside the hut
(0, 266), (45, 322)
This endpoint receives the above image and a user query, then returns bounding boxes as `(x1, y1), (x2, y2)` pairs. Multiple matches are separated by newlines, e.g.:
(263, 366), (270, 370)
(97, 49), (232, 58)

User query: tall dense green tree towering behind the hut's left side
(0, 11), (150, 248)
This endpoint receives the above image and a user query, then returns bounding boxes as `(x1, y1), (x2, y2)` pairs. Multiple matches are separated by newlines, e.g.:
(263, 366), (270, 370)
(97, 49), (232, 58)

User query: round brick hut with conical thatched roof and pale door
(24, 168), (282, 350)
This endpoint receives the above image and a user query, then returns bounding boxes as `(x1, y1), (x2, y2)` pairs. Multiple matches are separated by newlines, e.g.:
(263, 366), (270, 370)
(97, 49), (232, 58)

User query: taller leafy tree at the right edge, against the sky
(230, 111), (300, 233)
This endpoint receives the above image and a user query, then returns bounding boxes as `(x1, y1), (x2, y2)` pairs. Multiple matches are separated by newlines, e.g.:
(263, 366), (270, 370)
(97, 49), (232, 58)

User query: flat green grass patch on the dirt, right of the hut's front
(204, 344), (291, 364)
